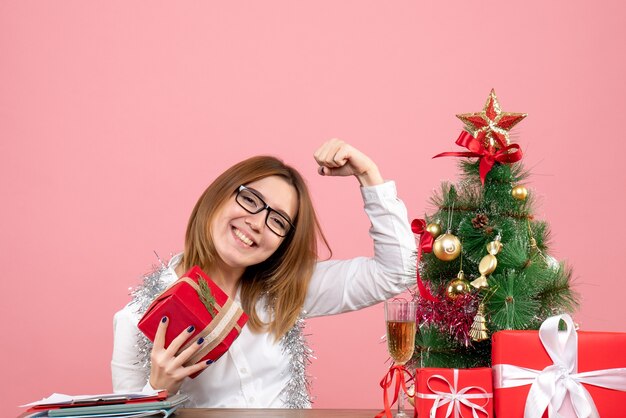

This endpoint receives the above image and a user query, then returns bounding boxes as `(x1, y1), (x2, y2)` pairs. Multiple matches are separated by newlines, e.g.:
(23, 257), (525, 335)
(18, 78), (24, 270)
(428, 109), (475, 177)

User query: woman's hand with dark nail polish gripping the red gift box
(150, 316), (211, 394)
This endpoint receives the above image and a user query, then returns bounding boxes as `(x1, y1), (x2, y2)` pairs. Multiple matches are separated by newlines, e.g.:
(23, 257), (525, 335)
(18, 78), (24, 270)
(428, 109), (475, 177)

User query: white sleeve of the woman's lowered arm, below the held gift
(111, 306), (152, 393)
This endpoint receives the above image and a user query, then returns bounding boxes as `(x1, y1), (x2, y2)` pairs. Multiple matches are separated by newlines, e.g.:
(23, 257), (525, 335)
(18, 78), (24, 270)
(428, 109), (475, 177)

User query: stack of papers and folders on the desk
(21, 391), (188, 418)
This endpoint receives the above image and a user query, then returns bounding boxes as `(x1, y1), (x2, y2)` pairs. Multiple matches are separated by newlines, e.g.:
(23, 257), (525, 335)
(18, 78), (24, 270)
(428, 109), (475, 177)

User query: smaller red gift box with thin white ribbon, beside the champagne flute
(415, 367), (492, 418)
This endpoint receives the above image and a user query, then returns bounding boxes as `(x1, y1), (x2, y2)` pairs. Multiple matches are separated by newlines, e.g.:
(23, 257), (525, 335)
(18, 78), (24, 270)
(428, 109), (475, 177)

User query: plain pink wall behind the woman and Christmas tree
(0, 0), (626, 415)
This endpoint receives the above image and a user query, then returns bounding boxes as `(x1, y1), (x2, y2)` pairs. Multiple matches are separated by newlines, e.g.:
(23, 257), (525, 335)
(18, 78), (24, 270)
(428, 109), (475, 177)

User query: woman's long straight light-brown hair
(182, 156), (330, 339)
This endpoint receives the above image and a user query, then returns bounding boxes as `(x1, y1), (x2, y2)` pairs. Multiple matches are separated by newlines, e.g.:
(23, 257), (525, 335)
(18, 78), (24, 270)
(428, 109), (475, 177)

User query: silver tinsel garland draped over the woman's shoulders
(130, 256), (315, 409)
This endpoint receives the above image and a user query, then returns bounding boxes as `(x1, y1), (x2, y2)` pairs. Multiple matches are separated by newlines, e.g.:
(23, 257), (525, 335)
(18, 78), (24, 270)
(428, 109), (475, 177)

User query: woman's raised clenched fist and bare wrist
(313, 139), (384, 186)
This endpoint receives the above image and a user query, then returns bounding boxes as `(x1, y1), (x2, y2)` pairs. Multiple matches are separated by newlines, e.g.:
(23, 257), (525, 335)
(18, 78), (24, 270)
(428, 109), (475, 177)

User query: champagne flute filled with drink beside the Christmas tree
(385, 300), (417, 418)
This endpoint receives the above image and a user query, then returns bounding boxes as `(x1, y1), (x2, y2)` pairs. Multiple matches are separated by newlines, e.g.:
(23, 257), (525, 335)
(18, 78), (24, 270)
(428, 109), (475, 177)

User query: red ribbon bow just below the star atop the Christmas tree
(433, 131), (522, 184)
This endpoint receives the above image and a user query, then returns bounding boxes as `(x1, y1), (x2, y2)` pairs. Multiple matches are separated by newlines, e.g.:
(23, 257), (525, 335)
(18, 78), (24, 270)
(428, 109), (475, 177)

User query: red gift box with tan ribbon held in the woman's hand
(137, 266), (248, 378)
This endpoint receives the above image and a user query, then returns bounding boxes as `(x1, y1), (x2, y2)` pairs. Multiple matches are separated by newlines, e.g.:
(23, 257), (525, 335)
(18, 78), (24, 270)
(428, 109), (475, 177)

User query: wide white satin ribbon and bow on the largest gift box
(493, 314), (626, 418)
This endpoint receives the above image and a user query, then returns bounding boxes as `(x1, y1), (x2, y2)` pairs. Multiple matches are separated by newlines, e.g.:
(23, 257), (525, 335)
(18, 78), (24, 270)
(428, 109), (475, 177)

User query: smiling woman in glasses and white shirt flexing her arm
(111, 140), (415, 408)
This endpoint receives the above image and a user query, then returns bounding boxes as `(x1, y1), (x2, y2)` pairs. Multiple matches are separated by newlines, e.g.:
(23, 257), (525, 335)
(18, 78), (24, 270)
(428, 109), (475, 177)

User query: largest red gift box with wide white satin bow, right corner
(492, 315), (626, 418)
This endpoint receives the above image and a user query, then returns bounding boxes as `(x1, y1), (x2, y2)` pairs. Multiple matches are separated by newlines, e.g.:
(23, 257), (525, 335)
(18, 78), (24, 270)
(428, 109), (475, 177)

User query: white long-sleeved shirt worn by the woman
(111, 181), (416, 408)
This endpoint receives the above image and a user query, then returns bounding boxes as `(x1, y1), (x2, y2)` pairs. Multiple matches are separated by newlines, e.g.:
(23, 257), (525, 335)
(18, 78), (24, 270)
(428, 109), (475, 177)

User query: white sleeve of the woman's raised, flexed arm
(304, 181), (416, 317)
